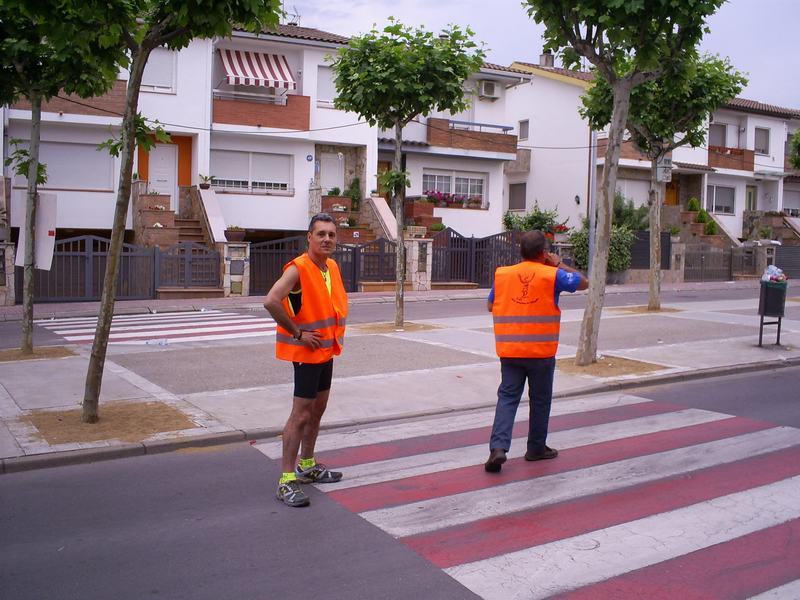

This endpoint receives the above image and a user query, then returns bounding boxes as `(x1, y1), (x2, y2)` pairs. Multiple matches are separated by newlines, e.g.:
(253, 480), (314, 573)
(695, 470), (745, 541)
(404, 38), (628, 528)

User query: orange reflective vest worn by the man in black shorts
(275, 254), (347, 364)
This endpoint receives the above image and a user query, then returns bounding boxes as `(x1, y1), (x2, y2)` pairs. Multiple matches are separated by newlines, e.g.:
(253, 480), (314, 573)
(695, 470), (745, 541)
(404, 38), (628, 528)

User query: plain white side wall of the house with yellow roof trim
(507, 75), (590, 232)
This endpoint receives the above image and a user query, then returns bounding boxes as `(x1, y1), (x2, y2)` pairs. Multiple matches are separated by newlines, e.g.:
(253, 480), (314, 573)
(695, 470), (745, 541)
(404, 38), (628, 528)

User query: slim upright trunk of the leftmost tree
(20, 92), (42, 355)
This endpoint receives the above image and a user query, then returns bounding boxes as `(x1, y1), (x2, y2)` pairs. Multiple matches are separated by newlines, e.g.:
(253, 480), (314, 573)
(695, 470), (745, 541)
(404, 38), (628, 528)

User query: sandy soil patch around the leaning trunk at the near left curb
(20, 402), (197, 445)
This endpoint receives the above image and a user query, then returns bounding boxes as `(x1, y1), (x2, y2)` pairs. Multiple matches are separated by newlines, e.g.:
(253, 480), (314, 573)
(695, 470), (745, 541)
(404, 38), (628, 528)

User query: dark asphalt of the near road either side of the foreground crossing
(0, 368), (800, 600)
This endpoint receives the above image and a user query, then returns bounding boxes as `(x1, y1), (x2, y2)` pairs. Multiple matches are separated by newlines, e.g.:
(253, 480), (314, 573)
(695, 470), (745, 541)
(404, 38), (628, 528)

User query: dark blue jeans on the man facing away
(489, 356), (556, 452)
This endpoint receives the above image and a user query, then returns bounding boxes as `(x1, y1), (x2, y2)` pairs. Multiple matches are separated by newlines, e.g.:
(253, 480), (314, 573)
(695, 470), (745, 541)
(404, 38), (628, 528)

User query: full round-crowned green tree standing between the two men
(333, 19), (484, 328)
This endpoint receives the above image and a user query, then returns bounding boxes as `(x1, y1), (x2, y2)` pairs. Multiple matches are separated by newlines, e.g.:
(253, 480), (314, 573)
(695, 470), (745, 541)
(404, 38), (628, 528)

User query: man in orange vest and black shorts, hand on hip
(264, 213), (347, 507)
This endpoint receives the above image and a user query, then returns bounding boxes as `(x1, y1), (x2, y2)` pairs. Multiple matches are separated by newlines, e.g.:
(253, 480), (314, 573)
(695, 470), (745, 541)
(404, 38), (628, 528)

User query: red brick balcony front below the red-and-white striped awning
(214, 95), (311, 131)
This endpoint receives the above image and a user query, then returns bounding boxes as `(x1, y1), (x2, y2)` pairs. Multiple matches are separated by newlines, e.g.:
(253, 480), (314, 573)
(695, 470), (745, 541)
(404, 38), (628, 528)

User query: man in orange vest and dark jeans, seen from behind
(484, 231), (589, 473)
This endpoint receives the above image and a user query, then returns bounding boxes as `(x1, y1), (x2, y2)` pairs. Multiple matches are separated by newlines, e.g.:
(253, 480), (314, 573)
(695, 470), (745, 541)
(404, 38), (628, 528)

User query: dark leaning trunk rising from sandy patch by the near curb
(81, 48), (150, 423)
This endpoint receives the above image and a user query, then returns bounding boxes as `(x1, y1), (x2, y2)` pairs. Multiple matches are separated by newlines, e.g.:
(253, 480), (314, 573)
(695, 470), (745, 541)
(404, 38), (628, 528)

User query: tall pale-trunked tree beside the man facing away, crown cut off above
(525, 0), (724, 366)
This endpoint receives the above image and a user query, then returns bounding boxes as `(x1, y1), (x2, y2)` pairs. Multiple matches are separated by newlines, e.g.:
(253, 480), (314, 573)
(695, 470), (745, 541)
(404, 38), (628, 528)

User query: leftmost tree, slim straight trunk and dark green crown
(0, 0), (124, 354)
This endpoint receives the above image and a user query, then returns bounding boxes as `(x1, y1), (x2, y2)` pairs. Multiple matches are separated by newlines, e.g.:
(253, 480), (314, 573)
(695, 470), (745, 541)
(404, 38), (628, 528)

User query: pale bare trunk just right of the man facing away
(575, 80), (632, 366)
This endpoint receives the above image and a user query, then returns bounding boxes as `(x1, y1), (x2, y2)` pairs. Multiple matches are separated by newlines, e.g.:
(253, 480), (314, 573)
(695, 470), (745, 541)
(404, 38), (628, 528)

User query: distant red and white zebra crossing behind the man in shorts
(34, 310), (276, 345)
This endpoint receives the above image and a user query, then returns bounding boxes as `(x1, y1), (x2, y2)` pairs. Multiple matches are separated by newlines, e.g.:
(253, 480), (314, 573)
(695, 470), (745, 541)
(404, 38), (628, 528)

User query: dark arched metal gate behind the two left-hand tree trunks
(14, 235), (155, 303)
